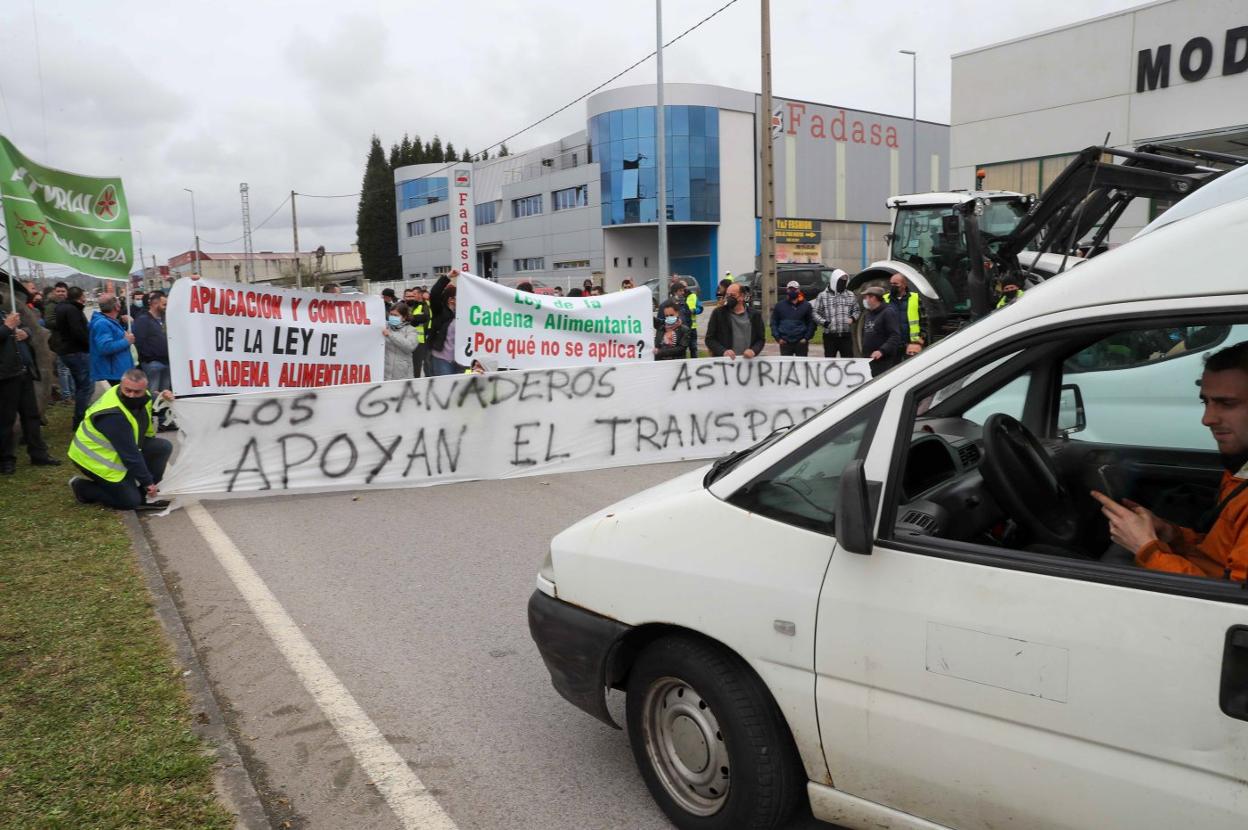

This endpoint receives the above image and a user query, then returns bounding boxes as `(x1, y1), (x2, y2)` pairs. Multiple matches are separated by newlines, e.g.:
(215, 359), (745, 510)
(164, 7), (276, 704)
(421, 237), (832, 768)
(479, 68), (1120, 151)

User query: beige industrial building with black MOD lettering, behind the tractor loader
(950, 0), (1248, 243)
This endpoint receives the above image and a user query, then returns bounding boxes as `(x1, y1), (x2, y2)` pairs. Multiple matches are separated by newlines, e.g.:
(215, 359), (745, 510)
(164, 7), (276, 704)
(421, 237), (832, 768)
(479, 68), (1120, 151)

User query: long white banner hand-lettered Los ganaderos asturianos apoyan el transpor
(161, 357), (871, 497)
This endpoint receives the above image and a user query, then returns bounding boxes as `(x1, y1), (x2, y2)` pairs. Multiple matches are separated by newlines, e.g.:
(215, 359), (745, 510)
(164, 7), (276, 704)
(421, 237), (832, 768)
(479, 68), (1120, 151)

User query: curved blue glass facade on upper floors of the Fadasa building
(589, 105), (719, 227)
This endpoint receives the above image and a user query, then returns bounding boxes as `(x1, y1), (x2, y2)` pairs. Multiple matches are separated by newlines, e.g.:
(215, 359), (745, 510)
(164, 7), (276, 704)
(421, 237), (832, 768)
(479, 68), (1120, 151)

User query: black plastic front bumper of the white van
(529, 590), (631, 729)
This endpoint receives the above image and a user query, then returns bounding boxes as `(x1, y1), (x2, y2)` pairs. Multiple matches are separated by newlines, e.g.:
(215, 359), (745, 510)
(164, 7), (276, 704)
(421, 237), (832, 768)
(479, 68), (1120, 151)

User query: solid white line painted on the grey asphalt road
(186, 502), (456, 830)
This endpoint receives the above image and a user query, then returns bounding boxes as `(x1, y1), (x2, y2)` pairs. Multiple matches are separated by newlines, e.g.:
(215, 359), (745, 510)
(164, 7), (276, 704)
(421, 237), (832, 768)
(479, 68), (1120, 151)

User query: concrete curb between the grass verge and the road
(121, 512), (272, 830)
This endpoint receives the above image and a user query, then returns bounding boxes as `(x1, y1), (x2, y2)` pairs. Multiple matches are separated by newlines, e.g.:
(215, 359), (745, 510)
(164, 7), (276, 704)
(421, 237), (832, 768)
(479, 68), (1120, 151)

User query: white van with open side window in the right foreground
(529, 168), (1248, 830)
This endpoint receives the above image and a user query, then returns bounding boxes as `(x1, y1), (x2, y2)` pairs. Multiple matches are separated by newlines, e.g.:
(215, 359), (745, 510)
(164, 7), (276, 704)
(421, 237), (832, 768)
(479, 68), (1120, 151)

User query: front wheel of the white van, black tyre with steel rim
(625, 637), (806, 830)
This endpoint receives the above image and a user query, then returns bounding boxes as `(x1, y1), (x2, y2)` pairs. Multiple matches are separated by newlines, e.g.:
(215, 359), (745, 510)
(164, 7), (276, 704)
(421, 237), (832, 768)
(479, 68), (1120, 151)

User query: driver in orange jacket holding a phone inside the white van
(1092, 342), (1248, 582)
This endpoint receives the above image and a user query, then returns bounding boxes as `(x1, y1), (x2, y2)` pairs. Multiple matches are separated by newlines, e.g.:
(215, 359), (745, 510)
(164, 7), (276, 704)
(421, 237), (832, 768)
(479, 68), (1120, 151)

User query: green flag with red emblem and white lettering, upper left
(0, 136), (134, 280)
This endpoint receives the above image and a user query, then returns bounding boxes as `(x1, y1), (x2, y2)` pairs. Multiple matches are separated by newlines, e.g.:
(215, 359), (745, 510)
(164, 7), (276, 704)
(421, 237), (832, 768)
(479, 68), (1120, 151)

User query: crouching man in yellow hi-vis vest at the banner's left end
(70, 369), (173, 510)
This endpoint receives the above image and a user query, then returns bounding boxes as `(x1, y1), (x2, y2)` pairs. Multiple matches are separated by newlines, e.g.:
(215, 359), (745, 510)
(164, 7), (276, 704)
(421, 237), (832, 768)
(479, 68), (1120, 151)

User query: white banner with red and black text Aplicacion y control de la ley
(166, 280), (386, 394)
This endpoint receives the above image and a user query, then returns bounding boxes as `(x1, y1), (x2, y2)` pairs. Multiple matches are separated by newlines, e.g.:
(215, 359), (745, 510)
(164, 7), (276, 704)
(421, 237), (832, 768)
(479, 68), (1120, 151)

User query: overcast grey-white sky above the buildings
(0, 0), (1138, 278)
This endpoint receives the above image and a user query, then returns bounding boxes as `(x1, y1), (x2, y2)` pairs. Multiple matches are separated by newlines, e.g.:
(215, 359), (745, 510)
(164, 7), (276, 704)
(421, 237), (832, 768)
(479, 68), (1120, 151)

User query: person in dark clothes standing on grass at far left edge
(0, 303), (61, 476)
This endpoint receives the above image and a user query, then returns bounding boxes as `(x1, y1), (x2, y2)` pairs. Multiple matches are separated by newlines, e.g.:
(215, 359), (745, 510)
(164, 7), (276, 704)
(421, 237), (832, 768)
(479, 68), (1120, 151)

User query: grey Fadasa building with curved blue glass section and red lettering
(394, 84), (948, 288)
